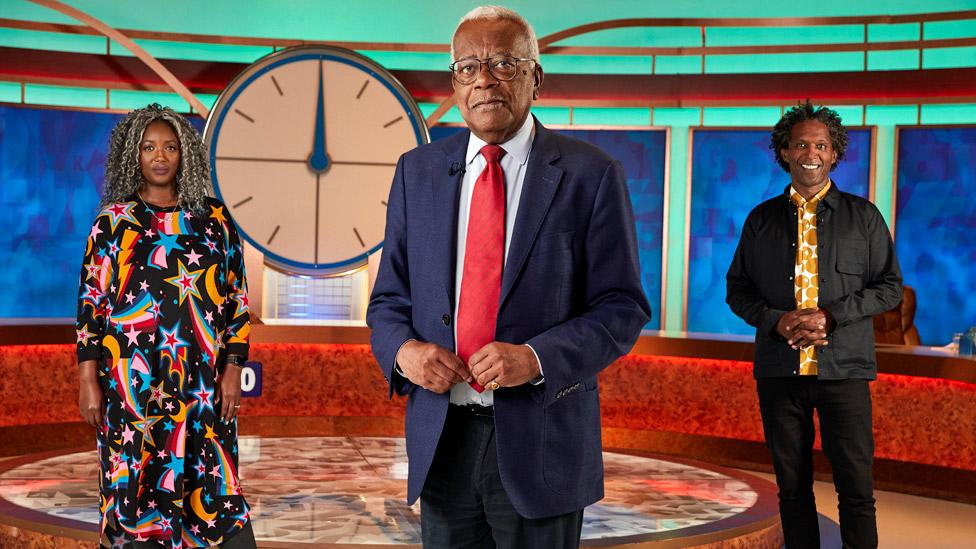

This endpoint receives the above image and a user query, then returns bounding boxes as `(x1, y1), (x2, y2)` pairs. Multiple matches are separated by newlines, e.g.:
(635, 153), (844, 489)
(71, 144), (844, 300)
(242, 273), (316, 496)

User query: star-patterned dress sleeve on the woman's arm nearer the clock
(224, 209), (251, 359)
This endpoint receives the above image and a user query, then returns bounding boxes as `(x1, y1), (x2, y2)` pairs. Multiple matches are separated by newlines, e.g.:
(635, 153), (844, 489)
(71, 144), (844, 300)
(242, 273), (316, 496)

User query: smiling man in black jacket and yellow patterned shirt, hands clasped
(726, 100), (901, 549)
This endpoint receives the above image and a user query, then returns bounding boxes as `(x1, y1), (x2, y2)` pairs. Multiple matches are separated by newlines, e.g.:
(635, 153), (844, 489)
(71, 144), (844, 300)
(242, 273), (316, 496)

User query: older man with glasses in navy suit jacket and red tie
(367, 7), (650, 548)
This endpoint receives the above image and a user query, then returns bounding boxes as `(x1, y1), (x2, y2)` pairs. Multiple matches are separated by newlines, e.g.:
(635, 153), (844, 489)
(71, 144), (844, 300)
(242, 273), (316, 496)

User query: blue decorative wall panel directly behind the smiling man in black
(686, 129), (871, 334)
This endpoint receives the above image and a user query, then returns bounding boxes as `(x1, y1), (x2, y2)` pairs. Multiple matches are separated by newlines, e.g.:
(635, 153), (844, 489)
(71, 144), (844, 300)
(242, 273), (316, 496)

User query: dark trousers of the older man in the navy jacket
(420, 405), (583, 549)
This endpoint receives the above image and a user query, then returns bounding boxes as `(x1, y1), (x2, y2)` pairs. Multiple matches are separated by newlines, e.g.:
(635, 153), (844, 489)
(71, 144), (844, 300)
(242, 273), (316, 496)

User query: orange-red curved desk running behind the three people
(0, 325), (976, 502)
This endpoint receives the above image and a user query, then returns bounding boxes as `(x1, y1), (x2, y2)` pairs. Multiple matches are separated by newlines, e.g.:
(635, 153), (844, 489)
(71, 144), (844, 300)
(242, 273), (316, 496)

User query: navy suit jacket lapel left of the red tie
(427, 126), (469, 311)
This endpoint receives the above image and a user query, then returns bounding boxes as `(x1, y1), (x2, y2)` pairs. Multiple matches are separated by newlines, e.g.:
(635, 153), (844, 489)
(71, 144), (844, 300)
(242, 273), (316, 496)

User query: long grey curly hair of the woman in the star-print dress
(101, 103), (213, 212)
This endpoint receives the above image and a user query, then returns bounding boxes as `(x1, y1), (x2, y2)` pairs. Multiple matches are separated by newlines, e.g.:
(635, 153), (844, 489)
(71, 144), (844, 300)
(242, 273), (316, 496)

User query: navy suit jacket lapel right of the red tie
(499, 120), (563, 310)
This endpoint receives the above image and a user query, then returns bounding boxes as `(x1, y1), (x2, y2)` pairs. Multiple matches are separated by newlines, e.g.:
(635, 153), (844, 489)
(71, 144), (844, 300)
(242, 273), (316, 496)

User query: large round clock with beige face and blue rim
(205, 46), (428, 275)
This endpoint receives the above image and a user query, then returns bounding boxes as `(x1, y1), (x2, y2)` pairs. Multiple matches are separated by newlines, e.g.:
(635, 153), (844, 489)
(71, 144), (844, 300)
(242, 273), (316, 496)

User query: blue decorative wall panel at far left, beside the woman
(0, 106), (203, 318)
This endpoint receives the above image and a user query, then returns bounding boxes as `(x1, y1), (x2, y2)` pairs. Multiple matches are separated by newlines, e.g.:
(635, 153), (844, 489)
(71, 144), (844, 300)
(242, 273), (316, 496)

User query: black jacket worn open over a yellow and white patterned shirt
(726, 182), (901, 379)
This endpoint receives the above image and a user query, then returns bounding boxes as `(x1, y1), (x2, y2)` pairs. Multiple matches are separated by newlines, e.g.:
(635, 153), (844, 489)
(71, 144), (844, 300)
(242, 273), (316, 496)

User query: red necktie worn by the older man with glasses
(457, 145), (505, 393)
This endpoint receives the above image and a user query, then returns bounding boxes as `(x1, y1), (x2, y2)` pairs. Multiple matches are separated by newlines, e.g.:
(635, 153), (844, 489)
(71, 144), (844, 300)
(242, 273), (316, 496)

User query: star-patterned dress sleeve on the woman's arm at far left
(75, 216), (113, 362)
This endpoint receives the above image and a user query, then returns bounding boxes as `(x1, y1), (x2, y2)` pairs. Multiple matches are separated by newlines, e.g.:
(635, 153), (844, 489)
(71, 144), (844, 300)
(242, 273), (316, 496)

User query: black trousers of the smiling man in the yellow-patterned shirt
(756, 376), (878, 549)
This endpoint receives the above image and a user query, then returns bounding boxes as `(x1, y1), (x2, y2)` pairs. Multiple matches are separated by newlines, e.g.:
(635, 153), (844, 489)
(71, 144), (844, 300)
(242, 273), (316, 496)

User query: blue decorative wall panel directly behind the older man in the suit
(430, 126), (667, 329)
